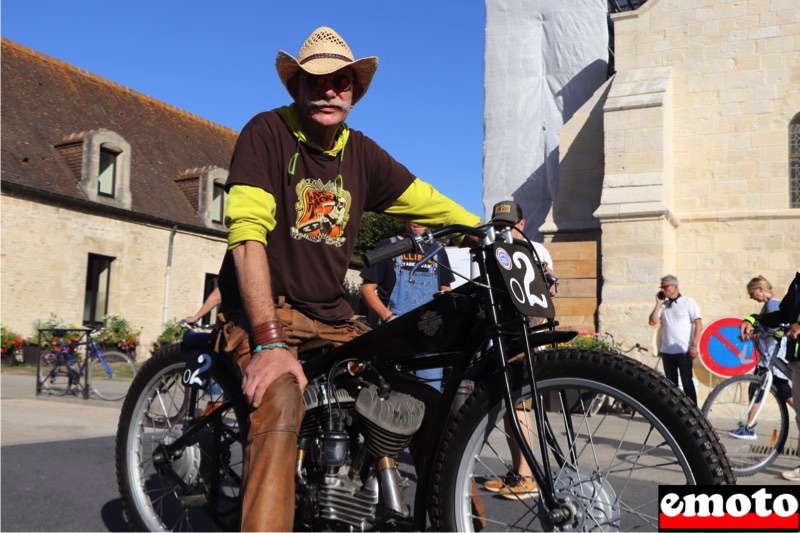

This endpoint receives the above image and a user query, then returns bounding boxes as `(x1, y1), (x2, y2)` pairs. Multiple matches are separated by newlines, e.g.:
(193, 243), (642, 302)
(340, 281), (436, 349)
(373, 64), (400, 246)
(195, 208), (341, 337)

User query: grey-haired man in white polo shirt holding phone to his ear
(650, 275), (703, 405)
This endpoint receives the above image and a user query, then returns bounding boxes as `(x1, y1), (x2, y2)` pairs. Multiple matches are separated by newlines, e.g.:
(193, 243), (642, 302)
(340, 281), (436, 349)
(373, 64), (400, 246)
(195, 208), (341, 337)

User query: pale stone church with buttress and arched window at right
(540, 0), (800, 390)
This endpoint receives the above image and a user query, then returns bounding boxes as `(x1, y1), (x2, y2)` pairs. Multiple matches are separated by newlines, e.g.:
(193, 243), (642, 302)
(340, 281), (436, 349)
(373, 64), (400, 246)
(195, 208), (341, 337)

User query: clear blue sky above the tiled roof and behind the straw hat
(0, 0), (485, 215)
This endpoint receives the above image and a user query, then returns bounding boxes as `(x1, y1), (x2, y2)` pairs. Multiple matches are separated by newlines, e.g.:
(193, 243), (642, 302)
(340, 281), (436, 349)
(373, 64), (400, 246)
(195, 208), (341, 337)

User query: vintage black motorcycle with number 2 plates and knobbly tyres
(116, 218), (734, 531)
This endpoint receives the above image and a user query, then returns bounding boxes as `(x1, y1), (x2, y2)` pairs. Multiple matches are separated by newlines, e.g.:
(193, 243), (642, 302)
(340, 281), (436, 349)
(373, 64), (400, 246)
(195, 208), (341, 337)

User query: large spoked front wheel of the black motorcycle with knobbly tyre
(431, 348), (734, 531)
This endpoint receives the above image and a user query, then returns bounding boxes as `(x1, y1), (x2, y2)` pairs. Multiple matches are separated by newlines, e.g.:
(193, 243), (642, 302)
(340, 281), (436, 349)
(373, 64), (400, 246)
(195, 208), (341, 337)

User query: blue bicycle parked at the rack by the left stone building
(36, 328), (136, 400)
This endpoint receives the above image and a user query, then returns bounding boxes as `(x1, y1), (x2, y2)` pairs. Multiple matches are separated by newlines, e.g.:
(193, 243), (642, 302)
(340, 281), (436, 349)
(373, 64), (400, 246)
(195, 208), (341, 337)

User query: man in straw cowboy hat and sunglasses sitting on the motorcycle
(218, 27), (479, 531)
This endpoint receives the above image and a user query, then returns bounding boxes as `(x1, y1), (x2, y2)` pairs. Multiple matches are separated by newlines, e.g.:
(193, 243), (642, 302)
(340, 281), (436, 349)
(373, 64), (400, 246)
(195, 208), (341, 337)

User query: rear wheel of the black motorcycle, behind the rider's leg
(116, 345), (248, 531)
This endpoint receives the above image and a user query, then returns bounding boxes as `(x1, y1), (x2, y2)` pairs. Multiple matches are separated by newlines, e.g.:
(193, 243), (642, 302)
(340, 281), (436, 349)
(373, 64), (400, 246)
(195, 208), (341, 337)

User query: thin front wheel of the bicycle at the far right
(703, 374), (789, 476)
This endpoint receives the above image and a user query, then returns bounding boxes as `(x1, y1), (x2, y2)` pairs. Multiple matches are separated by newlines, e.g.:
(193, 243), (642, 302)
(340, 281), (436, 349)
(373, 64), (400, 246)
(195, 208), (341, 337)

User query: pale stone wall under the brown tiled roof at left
(0, 193), (225, 358)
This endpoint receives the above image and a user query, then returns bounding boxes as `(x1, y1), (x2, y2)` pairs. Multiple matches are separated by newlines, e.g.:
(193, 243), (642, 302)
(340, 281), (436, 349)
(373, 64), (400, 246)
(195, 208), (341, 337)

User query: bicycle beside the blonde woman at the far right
(702, 324), (791, 476)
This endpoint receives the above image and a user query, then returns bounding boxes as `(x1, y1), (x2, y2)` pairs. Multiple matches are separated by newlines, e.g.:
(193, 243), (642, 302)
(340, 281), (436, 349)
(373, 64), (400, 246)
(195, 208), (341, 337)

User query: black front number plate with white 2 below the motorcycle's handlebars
(494, 243), (556, 318)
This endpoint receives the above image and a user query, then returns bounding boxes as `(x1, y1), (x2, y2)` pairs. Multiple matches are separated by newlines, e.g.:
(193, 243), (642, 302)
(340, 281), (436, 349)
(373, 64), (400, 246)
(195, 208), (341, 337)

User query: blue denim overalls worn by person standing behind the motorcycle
(389, 237), (444, 390)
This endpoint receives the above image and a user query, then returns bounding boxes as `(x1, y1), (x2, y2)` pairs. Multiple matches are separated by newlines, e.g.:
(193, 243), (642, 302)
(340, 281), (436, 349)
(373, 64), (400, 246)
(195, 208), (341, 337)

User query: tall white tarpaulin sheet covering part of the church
(483, 0), (608, 240)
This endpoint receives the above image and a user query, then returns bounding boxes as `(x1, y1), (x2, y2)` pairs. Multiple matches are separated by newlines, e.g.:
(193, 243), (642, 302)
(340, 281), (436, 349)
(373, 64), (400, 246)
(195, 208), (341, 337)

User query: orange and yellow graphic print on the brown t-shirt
(290, 179), (350, 246)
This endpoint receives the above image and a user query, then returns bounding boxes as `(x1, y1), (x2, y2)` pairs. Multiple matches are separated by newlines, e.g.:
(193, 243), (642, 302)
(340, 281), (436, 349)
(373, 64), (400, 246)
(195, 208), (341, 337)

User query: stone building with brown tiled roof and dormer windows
(0, 39), (237, 357)
